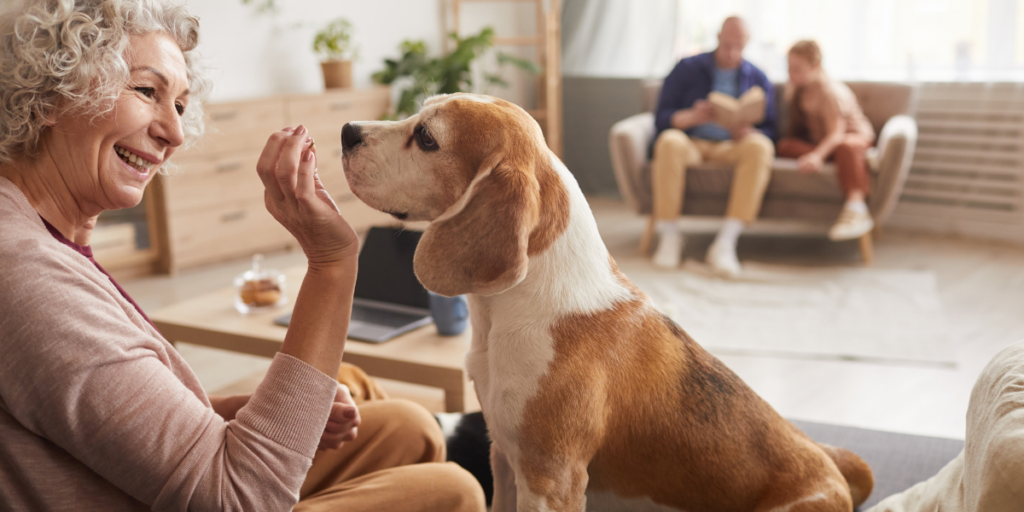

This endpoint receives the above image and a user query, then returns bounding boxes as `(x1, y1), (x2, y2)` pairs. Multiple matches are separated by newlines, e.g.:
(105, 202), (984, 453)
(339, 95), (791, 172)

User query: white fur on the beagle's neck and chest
(466, 157), (631, 459)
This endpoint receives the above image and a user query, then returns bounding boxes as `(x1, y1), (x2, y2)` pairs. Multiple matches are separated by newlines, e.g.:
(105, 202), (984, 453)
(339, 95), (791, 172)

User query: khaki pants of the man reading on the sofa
(651, 128), (775, 223)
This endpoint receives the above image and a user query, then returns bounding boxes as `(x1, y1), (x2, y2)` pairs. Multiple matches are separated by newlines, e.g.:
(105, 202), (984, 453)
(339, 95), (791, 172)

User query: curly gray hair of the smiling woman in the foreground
(0, 0), (209, 164)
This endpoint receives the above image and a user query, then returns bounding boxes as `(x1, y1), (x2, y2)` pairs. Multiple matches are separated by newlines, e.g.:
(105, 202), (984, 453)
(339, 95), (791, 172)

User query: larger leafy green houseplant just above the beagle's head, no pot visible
(373, 27), (540, 119)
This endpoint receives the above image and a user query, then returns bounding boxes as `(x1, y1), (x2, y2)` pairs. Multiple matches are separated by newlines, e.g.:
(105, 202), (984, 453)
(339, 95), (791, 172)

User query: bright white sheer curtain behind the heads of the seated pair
(676, 0), (1024, 81)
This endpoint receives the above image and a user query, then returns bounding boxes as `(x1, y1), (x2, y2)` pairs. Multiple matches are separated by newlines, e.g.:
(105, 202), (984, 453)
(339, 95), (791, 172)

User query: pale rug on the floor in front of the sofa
(618, 258), (955, 367)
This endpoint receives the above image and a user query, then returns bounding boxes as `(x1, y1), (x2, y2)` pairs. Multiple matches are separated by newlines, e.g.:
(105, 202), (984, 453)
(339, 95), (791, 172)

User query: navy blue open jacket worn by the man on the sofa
(651, 52), (775, 154)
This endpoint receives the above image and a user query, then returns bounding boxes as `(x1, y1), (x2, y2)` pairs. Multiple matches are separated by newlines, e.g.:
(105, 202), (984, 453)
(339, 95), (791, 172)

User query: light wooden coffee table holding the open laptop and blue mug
(150, 266), (478, 413)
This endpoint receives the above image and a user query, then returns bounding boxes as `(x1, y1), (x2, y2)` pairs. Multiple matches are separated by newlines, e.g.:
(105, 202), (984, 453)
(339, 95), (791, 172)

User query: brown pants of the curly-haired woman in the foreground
(294, 365), (485, 512)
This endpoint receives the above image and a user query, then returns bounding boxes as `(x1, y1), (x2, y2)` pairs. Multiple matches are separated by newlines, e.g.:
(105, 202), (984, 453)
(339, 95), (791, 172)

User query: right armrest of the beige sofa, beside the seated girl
(868, 116), (918, 224)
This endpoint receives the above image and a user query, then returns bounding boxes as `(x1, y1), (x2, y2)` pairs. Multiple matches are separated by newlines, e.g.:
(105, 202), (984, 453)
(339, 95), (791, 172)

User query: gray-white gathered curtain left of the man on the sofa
(562, 0), (678, 77)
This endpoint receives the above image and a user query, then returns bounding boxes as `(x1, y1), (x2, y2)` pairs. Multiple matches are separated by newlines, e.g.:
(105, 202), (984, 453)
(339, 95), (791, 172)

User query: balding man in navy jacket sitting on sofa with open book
(651, 16), (775, 276)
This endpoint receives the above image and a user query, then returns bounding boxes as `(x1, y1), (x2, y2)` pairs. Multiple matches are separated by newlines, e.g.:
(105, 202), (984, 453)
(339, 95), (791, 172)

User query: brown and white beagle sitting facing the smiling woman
(342, 94), (873, 512)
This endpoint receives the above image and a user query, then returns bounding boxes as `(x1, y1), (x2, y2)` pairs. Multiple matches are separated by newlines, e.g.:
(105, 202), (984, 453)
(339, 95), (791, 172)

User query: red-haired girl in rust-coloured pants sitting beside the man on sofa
(776, 41), (874, 241)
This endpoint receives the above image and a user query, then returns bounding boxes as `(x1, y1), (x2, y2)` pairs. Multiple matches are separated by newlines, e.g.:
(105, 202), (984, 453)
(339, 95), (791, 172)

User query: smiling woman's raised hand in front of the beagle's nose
(256, 126), (359, 267)
